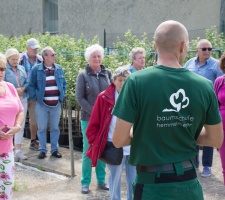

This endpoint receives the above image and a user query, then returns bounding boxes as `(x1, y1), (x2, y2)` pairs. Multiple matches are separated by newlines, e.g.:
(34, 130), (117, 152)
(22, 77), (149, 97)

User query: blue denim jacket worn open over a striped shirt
(28, 63), (66, 103)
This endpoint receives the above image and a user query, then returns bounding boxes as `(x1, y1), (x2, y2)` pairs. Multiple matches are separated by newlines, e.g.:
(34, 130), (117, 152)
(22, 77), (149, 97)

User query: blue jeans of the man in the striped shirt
(35, 102), (61, 153)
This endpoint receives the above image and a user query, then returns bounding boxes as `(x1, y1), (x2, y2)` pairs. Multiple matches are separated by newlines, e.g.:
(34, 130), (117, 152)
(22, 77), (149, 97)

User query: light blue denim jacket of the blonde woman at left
(4, 62), (28, 97)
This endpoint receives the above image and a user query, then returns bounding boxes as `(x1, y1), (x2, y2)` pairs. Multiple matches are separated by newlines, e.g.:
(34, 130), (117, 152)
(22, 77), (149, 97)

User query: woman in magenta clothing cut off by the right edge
(214, 52), (225, 185)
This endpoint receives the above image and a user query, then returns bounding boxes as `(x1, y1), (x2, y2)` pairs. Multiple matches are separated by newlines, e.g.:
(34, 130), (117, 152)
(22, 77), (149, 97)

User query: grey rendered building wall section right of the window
(59, 0), (220, 46)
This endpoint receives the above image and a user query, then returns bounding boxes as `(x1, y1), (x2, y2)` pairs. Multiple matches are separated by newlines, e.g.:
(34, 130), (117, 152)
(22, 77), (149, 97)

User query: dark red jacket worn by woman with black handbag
(86, 83), (115, 167)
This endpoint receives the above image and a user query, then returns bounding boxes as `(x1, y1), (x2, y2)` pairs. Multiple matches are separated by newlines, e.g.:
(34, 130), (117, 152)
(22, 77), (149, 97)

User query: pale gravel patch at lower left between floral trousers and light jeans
(13, 163), (110, 200)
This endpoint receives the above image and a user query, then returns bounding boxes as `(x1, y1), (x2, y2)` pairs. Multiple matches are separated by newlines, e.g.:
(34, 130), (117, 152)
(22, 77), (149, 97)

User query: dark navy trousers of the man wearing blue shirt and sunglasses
(196, 145), (213, 167)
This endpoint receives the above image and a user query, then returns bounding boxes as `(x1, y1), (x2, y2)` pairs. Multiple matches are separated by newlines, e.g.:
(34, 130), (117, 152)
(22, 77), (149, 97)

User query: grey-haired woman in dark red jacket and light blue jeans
(86, 67), (136, 200)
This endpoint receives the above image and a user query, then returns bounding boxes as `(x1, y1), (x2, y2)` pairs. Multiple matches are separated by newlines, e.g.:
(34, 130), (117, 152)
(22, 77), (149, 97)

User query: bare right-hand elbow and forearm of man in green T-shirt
(197, 123), (223, 148)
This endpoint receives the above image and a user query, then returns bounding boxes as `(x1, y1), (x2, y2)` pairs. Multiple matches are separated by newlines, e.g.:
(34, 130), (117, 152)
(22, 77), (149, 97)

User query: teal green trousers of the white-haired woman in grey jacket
(81, 120), (106, 186)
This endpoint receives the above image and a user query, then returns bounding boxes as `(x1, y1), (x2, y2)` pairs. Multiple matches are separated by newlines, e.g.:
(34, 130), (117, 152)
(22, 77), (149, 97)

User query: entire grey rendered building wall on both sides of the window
(0, 0), (221, 46)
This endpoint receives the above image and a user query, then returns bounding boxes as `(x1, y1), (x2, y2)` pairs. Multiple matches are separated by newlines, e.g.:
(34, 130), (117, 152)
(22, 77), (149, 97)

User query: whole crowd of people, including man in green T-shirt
(0, 20), (225, 200)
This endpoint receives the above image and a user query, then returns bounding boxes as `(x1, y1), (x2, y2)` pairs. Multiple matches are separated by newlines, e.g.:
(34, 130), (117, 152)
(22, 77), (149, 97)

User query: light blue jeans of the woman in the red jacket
(107, 155), (136, 200)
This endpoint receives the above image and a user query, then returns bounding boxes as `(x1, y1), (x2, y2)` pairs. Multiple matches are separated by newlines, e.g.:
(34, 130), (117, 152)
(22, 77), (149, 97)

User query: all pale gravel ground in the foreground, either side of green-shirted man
(13, 152), (225, 200)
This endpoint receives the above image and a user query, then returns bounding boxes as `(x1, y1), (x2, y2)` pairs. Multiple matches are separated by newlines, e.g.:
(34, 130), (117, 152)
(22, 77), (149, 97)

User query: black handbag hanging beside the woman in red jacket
(99, 141), (123, 165)
